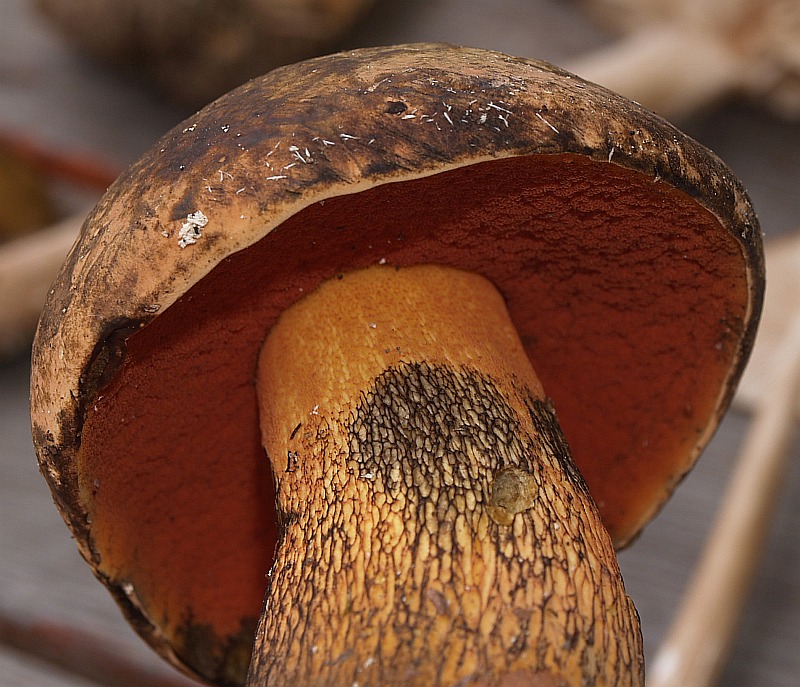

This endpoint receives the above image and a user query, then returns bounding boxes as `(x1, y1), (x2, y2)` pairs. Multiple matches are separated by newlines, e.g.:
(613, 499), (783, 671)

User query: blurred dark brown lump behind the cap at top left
(36, 0), (372, 105)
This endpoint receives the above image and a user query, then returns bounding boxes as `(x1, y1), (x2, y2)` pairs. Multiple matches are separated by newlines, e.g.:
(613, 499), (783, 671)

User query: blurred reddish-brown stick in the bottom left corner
(0, 611), (197, 687)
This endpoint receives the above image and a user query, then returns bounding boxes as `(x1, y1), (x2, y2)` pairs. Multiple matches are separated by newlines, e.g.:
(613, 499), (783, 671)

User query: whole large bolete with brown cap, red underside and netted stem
(32, 45), (763, 687)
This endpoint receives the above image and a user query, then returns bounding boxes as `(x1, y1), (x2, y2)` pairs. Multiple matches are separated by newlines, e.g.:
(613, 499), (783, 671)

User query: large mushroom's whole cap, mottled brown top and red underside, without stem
(31, 45), (764, 684)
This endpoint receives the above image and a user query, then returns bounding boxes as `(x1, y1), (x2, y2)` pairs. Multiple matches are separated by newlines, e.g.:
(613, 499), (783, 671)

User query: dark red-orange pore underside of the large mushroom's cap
(80, 155), (747, 656)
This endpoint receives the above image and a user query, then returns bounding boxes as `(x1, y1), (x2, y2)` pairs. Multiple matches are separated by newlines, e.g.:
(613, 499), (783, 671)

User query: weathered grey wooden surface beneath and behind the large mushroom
(0, 0), (800, 687)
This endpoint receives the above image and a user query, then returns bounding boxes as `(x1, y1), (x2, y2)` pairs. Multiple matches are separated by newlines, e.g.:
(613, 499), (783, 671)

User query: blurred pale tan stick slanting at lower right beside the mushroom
(647, 313), (800, 687)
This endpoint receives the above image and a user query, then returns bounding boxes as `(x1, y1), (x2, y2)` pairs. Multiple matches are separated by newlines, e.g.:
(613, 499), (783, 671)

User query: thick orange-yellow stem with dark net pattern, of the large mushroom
(248, 266), (643, 687)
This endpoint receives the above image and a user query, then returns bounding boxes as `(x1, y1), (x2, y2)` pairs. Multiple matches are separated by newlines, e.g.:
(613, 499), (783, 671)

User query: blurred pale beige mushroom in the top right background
(570, 0), (800, 117)
